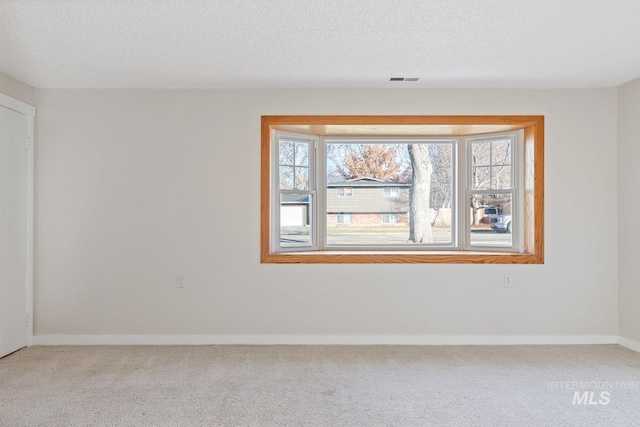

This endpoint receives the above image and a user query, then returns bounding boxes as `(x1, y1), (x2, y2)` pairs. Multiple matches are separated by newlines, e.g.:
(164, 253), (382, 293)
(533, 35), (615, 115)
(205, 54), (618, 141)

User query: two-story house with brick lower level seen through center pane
(327, 178), (411, 226)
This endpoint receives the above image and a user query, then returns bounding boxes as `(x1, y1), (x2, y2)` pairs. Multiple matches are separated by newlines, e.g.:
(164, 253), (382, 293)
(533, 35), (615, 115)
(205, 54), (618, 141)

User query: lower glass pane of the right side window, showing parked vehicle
(469, 193), (512, 246)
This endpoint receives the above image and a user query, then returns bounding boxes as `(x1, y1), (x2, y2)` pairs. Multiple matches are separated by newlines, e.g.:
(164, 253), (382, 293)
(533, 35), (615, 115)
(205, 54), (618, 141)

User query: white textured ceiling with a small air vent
(0, 0), (640, 88)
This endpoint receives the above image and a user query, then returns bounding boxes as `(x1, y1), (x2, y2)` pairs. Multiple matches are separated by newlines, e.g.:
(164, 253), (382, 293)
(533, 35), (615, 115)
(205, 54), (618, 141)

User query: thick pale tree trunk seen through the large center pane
(408, 144), (433, 243)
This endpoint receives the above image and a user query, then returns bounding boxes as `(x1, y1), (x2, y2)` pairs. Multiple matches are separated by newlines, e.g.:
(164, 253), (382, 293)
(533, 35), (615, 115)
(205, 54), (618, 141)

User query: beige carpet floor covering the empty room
(0, 345), (640, 427)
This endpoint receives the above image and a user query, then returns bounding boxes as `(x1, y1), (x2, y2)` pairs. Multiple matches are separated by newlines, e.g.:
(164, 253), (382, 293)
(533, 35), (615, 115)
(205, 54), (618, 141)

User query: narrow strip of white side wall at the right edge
(618, 79), (640, 342)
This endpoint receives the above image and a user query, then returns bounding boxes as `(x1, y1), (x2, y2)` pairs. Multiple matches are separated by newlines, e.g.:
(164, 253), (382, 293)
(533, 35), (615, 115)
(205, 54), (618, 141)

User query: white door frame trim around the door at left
(0, 93), (36, 347)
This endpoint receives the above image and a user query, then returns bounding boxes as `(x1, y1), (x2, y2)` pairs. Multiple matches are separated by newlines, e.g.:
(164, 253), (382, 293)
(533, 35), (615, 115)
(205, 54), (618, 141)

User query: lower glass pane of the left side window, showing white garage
(280, 194), (312, 246)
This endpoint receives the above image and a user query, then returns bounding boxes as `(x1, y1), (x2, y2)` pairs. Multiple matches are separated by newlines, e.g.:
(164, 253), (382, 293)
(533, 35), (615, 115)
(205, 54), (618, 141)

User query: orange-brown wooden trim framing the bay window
(260, 116), (544, 264)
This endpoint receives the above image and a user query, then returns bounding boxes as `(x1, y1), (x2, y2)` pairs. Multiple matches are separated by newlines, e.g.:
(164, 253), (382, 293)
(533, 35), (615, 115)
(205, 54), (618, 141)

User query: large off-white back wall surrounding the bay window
(35, 88), (618, 342)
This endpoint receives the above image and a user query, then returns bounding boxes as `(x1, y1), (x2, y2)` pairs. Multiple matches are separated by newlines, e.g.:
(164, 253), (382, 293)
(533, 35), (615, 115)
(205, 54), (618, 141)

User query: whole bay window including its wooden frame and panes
(262, 116), (544, 263)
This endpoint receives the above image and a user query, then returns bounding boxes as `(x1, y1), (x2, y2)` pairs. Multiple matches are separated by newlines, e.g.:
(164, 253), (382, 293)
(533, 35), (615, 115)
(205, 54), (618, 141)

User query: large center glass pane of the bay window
(325, 141), (455, 247)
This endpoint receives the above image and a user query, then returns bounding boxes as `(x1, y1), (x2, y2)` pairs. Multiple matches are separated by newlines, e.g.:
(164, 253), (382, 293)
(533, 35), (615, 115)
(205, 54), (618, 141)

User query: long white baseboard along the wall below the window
(33, 335), (620, 348)
